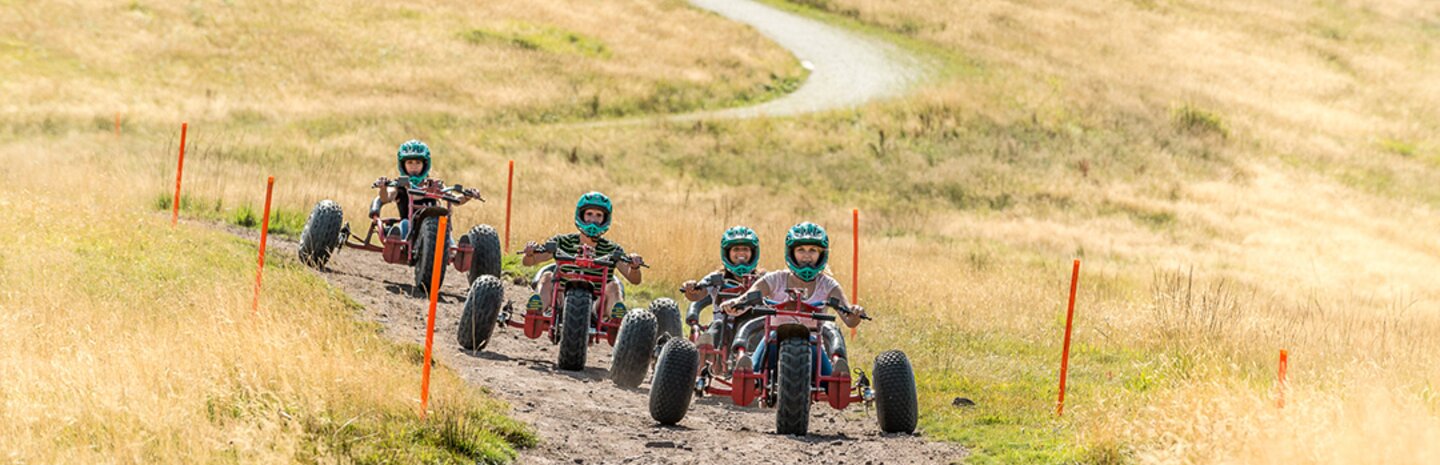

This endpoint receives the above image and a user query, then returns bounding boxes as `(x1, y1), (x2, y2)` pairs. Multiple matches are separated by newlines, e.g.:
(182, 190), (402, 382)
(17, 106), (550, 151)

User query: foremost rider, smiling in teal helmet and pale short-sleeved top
(720, 222), (865, 376)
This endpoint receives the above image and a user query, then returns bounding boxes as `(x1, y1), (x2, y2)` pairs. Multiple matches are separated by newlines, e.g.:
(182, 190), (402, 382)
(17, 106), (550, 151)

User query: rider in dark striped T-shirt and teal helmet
(521, 191), (645, 321)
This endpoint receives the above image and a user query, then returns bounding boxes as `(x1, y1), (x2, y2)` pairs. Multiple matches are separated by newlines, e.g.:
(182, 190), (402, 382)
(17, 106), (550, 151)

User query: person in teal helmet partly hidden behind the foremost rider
(680, 226), (765, 355)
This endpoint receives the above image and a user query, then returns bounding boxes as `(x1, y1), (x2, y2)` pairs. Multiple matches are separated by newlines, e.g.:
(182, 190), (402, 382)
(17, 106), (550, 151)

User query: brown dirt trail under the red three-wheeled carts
(229, 227), (965, 464)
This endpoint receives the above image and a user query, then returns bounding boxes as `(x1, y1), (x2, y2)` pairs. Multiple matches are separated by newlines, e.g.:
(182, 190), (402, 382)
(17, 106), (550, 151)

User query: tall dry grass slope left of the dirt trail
(0, 141), (534, 464)
